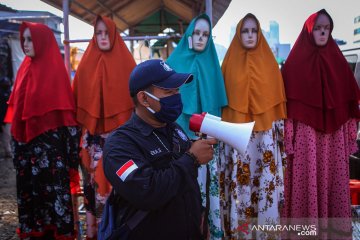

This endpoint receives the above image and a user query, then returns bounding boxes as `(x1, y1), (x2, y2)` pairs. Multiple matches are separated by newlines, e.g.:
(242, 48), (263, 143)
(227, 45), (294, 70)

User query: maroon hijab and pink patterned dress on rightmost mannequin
(282, 9), (360, 239)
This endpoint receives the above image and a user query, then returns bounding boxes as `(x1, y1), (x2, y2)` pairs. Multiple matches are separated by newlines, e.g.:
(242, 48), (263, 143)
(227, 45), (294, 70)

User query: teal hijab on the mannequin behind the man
(167, 14), (227, 138)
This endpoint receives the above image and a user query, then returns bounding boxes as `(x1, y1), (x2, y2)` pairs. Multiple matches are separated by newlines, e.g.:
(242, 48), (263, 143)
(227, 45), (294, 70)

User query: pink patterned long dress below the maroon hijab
(285, 119), (357, 218)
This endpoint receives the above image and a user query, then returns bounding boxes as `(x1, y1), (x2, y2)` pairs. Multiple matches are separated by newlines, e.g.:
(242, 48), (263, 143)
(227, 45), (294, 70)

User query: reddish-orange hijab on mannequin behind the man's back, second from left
(73, 16), (136, 134)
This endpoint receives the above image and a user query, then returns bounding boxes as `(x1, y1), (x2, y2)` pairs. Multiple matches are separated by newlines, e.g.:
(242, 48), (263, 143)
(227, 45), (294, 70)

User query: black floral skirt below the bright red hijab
(14, 127), (79, 239)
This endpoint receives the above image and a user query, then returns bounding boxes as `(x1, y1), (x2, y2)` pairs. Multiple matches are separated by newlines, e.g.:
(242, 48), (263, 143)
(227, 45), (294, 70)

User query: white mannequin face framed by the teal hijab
(192, 18), (210, 52)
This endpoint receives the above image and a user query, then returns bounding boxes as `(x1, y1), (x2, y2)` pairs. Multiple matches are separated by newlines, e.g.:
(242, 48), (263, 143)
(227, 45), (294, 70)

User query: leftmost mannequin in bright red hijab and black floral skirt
(6, 22), (80, 239)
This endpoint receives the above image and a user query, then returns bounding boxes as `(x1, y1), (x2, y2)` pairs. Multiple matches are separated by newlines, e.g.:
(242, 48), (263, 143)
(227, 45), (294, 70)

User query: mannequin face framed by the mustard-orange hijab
(241, 18), (259, 49)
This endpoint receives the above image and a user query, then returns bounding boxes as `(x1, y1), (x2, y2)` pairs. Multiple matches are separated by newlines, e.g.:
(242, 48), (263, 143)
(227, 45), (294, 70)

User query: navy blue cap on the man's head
(129, 59), (193, 96)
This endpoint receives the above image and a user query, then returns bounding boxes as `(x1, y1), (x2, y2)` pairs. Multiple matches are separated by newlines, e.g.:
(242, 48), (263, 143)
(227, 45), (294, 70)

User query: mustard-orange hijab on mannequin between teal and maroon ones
(221, 13), (286, 131)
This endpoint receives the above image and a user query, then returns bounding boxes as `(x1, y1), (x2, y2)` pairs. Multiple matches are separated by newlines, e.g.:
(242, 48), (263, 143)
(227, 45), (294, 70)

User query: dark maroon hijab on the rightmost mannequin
(282, 9), (360, 133)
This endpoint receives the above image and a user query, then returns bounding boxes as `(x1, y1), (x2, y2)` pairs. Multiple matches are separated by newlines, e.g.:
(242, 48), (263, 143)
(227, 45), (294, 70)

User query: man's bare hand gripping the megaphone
(189, 138), (217, 164)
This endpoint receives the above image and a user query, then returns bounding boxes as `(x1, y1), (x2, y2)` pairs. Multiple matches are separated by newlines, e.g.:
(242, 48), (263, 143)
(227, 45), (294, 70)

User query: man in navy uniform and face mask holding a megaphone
(103, 60), (217, 240)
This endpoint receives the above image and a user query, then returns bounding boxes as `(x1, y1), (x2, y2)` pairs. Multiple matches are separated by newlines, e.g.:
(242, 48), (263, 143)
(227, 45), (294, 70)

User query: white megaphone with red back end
(189, 113), (255, 154)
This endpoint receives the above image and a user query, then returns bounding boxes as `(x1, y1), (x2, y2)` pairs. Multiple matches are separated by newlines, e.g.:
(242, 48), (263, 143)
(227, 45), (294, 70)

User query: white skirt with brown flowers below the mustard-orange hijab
(220, 121), (286, 239)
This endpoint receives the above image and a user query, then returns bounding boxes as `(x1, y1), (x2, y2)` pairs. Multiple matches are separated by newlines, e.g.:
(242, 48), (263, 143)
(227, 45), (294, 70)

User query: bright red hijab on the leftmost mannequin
(7, 22), (77, 142)
